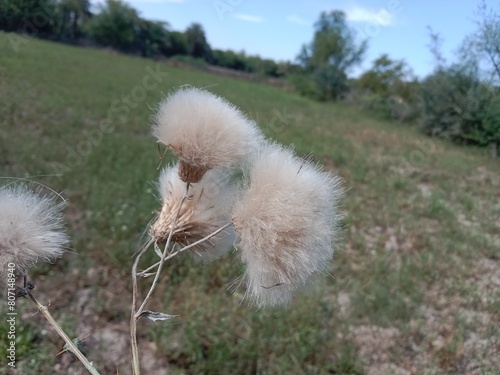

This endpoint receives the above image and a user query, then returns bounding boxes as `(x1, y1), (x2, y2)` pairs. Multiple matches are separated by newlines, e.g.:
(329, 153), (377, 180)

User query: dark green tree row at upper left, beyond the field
(0, 0), (299, 77)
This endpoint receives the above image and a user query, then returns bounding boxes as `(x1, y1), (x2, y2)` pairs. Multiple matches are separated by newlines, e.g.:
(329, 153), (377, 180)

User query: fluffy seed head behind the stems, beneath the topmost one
(149, 165), (235, 260)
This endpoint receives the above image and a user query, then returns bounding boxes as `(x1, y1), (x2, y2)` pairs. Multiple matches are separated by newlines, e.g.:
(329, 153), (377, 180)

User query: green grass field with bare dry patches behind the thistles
(0, 33), (500, 375)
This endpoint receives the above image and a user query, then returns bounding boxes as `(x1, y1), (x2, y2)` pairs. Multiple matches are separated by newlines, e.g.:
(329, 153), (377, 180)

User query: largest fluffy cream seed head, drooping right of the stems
(232, 144), (342, 306)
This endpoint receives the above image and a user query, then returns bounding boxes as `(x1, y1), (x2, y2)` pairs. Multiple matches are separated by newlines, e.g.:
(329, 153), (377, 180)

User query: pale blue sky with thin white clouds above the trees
(93, 0), (500, 77)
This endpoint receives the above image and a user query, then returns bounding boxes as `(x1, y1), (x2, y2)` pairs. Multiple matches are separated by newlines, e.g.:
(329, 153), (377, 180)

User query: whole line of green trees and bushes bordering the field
(0, 0), (500, 154)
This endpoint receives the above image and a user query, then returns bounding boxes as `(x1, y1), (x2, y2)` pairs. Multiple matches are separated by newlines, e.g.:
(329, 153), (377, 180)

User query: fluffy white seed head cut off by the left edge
(0, 186), (68, 285)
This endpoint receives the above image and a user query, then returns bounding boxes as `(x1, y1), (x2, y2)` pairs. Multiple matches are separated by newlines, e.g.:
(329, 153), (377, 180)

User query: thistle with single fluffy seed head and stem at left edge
(0, 185), (99, 375)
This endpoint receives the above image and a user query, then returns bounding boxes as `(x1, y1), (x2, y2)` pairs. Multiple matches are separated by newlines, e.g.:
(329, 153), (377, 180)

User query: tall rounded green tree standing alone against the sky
(298, 10), (368, 100)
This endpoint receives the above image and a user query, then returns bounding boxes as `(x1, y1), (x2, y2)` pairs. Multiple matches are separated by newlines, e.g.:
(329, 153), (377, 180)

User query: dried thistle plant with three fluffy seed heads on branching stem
(130, 88), (343, 374)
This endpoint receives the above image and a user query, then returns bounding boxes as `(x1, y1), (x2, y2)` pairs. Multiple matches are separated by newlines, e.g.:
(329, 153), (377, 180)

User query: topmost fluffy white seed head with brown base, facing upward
(153, 87), (263, 182)
